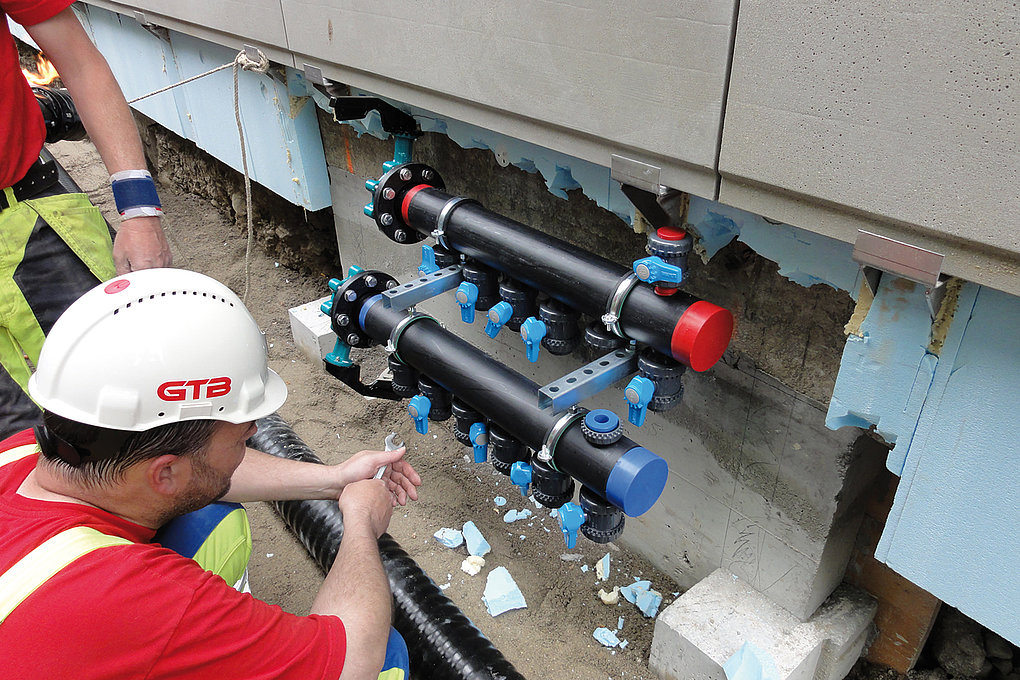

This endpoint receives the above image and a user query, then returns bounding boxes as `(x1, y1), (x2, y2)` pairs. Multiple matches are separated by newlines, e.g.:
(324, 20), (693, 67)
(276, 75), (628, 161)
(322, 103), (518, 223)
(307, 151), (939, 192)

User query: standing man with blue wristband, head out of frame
(0, 0), (170, 438)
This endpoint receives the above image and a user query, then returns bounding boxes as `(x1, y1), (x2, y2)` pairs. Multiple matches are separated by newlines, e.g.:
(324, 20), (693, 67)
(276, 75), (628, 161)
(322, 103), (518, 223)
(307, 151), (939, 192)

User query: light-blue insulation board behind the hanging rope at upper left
(78, 7), (332, 210)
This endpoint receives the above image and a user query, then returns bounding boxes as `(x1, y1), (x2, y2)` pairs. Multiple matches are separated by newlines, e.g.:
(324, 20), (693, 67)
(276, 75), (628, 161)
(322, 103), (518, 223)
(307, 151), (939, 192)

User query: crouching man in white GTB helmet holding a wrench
(0, 269), (421, 680)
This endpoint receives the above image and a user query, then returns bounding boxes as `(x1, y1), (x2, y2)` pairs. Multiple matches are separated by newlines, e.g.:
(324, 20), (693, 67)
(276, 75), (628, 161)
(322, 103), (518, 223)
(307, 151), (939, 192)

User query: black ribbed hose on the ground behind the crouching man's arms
(249, 414), (524, 680)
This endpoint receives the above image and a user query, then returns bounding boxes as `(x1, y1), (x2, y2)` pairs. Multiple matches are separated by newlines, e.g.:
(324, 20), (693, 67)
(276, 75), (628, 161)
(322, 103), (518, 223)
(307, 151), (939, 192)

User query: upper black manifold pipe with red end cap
(401, 185), (733, 371)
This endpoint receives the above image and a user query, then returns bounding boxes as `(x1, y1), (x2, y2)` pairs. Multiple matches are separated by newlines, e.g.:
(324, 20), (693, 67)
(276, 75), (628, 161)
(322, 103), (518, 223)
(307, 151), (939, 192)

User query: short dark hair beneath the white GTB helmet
(40, 411), (219, 486)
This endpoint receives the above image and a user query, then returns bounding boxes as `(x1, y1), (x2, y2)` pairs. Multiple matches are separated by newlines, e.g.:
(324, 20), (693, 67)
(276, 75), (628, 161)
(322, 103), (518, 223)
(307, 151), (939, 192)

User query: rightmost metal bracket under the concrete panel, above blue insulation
(852, 229), (949, 320)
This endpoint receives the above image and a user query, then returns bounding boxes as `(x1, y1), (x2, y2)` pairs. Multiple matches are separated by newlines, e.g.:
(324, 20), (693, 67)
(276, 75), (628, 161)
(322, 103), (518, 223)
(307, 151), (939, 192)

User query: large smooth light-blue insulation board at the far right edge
(876, 283), (1020, 644)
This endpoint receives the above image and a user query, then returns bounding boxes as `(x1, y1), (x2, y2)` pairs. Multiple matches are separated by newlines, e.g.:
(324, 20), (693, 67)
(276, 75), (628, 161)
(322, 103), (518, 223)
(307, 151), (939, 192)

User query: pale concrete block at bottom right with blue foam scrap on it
(649, 569), (875, 680)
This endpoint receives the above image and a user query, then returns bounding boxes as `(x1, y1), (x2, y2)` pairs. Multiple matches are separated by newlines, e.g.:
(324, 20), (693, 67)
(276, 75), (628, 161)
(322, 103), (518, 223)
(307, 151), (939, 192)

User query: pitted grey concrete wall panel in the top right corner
(719, 0), (1020, 292)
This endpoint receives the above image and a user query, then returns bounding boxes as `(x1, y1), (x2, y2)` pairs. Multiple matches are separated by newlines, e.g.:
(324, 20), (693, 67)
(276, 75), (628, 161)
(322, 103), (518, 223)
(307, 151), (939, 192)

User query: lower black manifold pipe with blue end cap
(358, 296), (669, 517)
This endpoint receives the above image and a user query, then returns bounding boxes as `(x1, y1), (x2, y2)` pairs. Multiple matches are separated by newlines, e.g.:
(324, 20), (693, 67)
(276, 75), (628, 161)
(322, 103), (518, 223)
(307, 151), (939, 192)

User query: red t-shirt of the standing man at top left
(0, 0), (73, 189)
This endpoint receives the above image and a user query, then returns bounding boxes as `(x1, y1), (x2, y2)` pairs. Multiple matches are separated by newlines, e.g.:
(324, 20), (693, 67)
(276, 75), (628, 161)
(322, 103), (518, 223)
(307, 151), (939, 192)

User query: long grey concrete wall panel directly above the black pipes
(283, 0), (733, 197)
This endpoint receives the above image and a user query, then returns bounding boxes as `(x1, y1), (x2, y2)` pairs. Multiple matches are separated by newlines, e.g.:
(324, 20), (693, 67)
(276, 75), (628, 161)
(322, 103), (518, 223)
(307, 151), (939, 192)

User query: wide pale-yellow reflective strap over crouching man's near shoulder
(0, 526), (132, 623)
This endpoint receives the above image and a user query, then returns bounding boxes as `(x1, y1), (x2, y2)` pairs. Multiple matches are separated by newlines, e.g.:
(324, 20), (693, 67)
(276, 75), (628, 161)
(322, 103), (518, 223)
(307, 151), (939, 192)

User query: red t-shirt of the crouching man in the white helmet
(0, 430), (346, 680)
